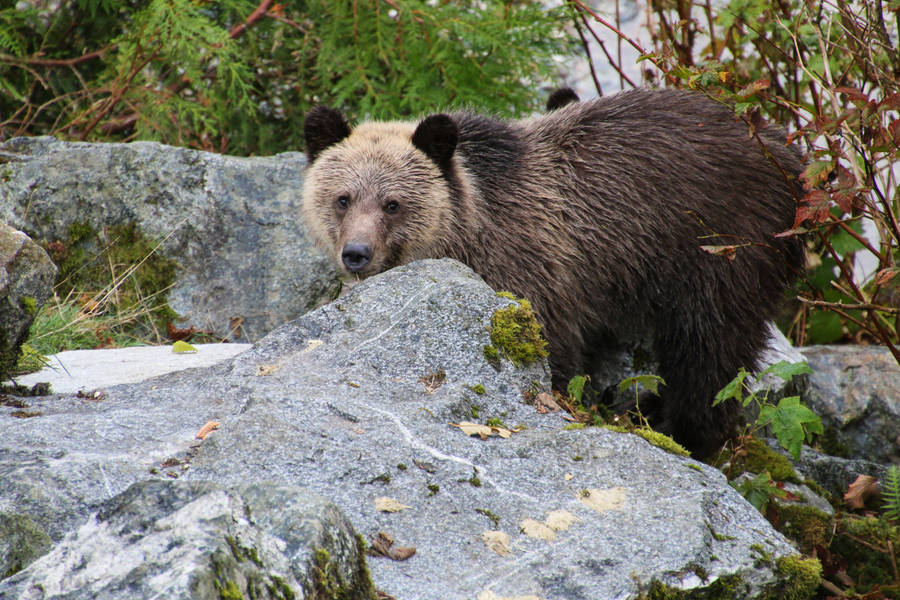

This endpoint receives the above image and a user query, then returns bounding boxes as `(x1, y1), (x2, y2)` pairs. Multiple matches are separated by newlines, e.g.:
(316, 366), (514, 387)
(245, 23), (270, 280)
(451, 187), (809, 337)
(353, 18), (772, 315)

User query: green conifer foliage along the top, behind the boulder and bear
(0, 0), (571, 155)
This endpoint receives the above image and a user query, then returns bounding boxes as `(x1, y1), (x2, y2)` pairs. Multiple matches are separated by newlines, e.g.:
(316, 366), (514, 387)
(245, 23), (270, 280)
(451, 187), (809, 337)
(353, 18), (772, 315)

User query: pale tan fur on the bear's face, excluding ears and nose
(303, 121), (451, 276)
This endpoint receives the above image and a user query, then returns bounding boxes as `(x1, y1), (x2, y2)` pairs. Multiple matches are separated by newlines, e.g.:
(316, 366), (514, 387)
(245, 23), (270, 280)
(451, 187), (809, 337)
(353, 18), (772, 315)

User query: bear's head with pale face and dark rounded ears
(303, 106), (458, 277)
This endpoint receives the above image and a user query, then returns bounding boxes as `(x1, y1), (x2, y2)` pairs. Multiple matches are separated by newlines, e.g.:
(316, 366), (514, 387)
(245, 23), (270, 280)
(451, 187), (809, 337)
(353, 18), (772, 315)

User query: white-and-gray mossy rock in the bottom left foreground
(0, 481), (374, 600)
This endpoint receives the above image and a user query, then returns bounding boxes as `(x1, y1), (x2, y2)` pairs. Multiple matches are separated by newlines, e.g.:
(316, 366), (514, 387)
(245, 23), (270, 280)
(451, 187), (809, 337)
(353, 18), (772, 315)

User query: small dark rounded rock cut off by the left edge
(0, 223), (56, 381)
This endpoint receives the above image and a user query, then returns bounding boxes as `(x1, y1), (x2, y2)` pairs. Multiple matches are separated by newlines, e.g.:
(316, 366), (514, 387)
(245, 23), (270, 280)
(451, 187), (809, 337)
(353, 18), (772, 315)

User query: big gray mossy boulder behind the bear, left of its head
(0, 137), (340, 341)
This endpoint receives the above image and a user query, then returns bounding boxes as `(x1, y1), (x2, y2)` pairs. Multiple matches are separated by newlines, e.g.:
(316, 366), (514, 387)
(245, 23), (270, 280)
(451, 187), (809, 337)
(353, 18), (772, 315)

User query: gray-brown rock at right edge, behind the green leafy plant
(802, 346), (900, 463)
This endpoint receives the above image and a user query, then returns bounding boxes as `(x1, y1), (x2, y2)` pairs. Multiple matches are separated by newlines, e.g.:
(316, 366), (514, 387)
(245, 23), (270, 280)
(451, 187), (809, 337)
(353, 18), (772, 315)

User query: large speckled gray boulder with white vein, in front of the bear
(0, 260), (796, 600)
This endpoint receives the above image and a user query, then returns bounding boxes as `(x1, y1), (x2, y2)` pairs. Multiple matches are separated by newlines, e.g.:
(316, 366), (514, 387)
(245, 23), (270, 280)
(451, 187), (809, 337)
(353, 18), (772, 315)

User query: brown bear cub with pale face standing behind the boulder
(303, 90), (804, 456)
